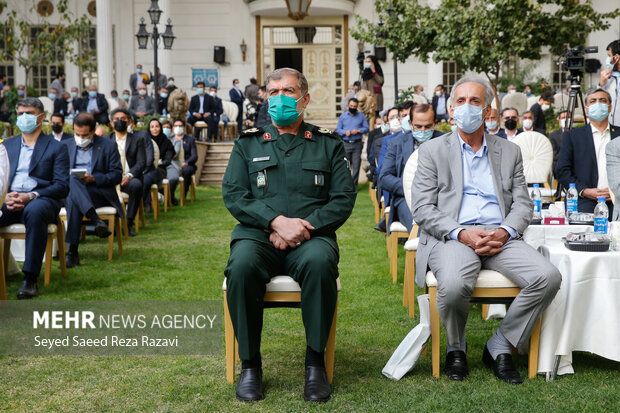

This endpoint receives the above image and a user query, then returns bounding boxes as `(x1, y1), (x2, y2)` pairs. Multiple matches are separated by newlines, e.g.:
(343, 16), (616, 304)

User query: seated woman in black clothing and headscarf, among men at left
(142, 119), (174, 212)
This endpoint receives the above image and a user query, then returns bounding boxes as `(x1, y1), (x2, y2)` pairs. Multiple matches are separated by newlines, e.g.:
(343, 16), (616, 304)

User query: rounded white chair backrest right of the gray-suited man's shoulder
(512, 131), (553, 184)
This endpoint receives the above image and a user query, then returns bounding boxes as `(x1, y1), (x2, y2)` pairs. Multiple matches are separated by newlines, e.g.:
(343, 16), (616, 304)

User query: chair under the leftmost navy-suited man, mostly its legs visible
(0, 221), (67, 300)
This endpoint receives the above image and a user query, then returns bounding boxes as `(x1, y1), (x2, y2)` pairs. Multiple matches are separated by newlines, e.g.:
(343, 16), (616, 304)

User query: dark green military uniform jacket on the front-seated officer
(222, 122), (357, 248)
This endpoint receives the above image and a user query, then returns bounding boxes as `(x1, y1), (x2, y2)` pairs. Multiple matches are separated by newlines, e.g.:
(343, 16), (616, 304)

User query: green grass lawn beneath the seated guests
(0, 186), (620, 412)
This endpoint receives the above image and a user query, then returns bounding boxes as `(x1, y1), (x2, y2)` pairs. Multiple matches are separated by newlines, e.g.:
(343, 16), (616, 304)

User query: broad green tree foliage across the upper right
(350, 0), (620, 108)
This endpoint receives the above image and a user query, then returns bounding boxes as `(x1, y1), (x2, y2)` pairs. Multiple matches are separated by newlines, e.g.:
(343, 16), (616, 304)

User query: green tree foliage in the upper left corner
(0, 0), (95, 90)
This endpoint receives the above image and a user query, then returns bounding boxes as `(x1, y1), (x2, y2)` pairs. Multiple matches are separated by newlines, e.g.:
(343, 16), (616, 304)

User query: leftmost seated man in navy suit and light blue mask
(0, 98), (69, 299)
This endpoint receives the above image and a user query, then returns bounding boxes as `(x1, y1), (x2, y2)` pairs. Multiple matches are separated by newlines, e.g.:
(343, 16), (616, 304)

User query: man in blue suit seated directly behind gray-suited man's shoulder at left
(379, 104), (442, 234)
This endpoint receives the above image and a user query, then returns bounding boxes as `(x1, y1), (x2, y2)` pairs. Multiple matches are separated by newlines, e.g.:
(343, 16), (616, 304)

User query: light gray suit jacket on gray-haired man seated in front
(411, 132), (532, 286)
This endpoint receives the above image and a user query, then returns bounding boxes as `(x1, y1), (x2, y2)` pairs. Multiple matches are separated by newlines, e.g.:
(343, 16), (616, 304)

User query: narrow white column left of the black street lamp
(97, 0), (114, 96)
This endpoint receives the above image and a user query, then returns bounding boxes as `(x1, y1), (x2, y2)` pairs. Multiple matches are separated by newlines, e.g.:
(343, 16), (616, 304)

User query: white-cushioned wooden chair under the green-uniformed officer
(222, 275), (341, 383)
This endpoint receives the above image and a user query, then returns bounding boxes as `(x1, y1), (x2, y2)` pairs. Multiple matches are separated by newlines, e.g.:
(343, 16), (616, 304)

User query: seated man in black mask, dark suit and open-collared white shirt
(109, 108), (146, 233)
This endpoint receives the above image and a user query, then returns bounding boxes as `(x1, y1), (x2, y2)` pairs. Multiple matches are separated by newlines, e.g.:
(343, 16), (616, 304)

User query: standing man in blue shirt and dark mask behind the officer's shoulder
(336, 98), (369, 186)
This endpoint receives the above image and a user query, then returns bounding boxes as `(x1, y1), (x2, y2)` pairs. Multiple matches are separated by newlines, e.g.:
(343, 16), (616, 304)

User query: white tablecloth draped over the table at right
(538, 243), (620, 374)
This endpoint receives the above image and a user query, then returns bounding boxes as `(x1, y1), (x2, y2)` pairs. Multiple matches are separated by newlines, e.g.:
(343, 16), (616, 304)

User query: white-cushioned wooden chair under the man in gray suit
(426, 270), (540, 378)
